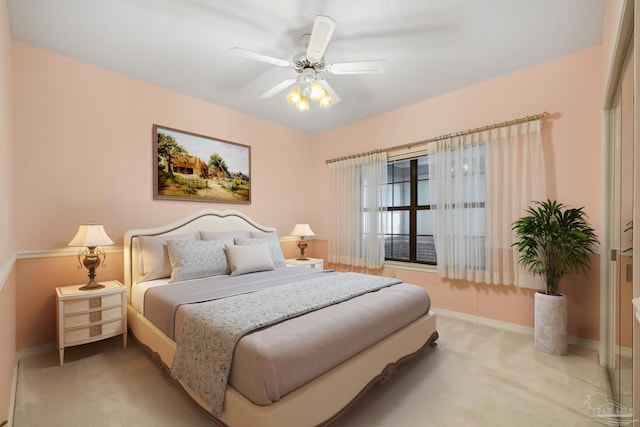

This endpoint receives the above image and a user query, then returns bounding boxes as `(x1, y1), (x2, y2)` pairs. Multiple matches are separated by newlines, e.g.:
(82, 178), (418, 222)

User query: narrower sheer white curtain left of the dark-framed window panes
(328, 152), (387, 268)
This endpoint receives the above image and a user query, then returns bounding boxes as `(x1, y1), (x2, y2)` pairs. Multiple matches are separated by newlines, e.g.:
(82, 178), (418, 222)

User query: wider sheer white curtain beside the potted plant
(431, 120), (546, 287)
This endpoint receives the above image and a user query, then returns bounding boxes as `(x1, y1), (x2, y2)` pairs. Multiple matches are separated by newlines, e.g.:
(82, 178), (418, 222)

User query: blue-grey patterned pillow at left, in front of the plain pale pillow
(167, 239), (233, 282)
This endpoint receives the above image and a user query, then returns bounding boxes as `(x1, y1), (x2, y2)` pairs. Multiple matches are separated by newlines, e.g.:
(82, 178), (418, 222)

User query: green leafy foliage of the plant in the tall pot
(512, 200), (598, 295)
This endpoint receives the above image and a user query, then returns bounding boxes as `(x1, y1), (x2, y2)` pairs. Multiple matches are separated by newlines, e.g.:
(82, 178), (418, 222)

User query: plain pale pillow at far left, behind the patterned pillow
(138, 233), (198, 282)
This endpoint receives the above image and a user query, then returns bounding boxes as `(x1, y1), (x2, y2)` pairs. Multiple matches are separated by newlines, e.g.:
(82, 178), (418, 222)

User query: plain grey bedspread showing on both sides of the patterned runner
(140, 267), (430, 412)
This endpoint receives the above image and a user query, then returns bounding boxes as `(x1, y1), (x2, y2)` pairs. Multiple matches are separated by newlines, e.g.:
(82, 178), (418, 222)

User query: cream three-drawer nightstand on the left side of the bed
(56, 280), (127, 366)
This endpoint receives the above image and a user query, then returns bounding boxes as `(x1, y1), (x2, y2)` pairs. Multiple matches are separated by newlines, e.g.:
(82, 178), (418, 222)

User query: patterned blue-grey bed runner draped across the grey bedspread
(171, 273), (399, 417)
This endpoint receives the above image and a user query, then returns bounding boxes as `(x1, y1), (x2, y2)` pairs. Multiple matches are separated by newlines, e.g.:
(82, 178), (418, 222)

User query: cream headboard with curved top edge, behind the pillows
(124, 209), (276, 298)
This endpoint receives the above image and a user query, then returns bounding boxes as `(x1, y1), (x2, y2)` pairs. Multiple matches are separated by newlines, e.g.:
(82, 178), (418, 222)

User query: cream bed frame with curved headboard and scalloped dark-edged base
(124, 210), (438, 427)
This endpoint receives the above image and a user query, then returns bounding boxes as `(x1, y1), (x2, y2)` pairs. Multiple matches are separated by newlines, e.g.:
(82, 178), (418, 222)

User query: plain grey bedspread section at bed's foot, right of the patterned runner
(229, 283), (431, 405)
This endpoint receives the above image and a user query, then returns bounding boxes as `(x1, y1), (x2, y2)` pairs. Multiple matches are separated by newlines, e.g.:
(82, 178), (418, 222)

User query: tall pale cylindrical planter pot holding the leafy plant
(534, 292), (567, 354)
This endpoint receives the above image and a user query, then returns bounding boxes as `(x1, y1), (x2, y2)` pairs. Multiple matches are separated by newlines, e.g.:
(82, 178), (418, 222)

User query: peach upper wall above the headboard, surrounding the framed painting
(13, 42), (310, 251)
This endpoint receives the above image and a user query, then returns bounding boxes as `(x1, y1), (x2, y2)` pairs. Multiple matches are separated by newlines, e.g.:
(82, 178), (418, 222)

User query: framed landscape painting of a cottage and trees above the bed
(153, 125), (251, 204)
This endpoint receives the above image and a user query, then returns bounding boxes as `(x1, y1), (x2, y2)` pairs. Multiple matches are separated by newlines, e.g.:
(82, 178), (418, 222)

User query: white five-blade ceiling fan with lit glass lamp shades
(231, 15), (385, 111)
